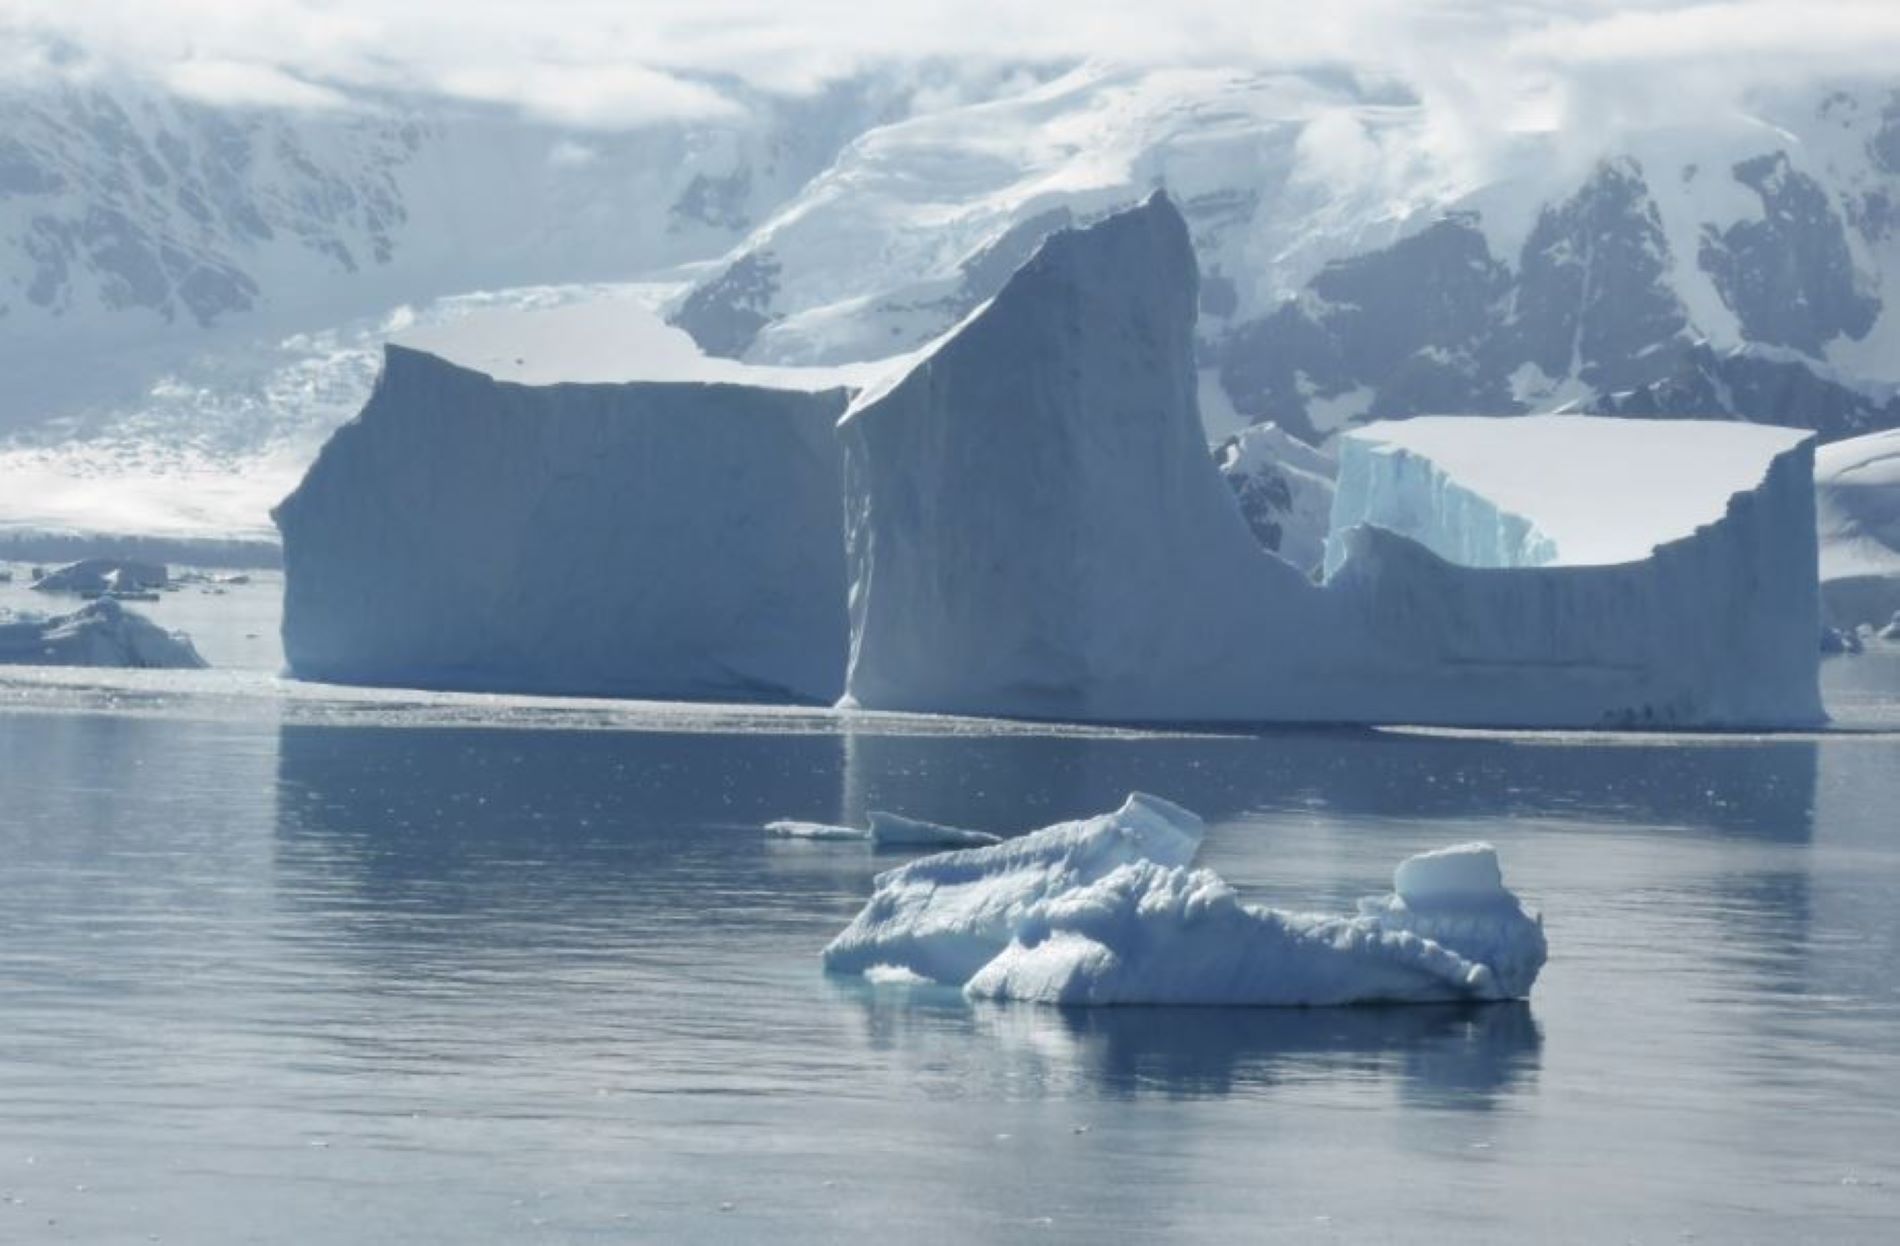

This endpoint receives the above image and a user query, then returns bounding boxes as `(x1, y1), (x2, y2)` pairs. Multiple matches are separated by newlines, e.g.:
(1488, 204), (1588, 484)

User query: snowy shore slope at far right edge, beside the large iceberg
(1815, 431), (1900, 629)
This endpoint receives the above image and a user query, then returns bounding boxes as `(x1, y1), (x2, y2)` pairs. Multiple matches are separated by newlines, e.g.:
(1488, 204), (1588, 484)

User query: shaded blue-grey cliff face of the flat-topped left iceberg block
(276, 348), (847, 701)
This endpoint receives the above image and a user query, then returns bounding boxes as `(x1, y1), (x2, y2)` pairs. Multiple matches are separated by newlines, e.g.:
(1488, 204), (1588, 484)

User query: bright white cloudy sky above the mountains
(0, 0), (1900, 127)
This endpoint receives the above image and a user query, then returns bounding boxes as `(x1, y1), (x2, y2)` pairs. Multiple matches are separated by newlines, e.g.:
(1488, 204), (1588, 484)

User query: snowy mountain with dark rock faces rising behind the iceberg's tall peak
(673, 66), (1900, 439)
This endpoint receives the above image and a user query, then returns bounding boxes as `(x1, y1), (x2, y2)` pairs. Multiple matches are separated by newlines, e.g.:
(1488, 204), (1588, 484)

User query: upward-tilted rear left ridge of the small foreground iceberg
(825, 794), (1205, 986)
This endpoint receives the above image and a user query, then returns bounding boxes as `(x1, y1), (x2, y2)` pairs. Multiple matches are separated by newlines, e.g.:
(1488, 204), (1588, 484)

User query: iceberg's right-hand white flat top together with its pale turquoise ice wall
(1328, 416), (1813, 566)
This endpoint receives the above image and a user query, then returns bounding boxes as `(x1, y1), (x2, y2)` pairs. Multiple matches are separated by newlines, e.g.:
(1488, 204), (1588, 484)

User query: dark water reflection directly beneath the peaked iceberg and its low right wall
(842, 729), (1816, 841)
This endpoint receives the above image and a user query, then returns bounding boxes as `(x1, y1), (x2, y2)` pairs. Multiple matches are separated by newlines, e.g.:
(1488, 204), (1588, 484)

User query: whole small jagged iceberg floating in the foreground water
(825, 794), (1547, 1007)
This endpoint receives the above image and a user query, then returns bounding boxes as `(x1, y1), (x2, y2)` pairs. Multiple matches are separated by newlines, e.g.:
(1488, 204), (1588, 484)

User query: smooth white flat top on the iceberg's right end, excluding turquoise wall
(1345, 416), (1813, 566)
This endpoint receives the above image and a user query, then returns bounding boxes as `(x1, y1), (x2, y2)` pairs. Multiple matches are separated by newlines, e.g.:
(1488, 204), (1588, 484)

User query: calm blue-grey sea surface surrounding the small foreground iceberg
(0, 577), (1900, 1246)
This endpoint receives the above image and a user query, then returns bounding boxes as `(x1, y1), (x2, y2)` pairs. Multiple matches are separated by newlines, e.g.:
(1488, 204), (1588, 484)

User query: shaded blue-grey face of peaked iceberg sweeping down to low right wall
(840, 192), (1824, 727)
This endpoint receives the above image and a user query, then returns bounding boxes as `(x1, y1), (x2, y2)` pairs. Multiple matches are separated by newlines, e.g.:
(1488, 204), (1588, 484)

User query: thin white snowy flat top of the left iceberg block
(391, 296), (884, 393)
